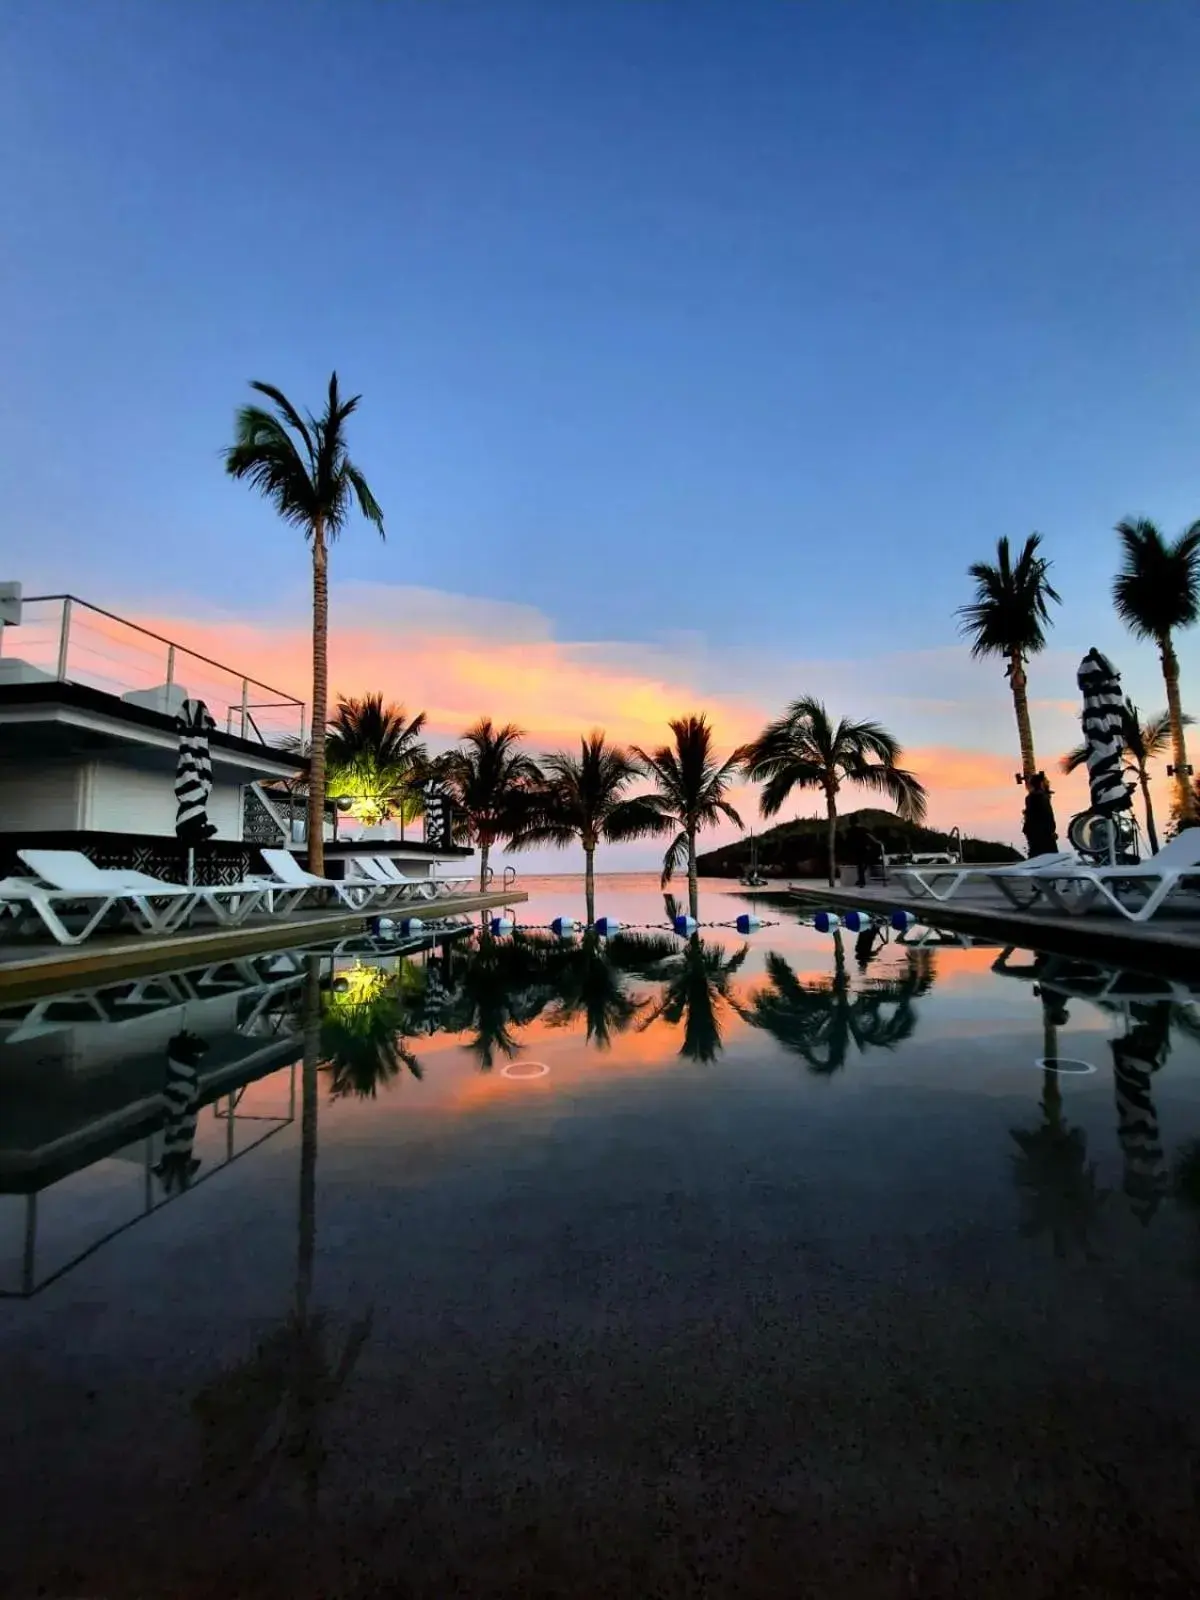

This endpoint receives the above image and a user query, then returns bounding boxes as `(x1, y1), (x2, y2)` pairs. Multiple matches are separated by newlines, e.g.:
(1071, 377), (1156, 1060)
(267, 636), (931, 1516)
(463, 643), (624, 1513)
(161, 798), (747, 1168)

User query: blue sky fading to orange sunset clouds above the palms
(0, 0), (1200, 866)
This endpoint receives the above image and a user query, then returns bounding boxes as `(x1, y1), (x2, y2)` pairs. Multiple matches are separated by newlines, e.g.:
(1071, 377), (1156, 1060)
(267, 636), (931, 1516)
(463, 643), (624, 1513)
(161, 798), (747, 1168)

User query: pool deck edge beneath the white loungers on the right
(784, 882), (1200, 976)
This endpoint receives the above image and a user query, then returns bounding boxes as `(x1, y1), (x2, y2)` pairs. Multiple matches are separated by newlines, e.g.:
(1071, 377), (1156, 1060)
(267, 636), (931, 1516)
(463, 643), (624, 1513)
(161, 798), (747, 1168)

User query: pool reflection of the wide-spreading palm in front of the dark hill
(738, 933), (933, 1075)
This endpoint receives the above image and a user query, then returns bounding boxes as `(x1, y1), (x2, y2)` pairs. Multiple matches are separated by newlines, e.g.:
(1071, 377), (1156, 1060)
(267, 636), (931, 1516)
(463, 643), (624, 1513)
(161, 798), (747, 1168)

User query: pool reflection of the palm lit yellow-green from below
(320, 966), (421, 1099)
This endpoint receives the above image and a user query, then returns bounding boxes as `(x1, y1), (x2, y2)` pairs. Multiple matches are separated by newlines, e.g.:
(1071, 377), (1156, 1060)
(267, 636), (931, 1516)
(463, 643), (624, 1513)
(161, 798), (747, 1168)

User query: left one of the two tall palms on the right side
(958, 533), (1059, 787)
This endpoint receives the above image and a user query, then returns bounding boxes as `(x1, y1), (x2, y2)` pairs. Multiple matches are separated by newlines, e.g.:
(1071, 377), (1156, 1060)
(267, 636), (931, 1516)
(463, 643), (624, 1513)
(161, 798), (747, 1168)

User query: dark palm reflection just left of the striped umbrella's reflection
(1011, 1067), (1107, 1259)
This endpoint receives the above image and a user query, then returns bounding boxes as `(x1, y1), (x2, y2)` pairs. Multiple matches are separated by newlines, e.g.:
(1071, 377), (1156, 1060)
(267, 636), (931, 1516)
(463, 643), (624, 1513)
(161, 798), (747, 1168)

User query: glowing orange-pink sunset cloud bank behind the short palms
(131, 584), (1107, 846)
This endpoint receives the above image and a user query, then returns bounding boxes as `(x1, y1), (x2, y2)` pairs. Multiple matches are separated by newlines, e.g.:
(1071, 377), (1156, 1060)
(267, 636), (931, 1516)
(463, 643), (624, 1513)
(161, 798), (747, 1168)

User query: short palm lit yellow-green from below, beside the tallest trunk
(325, 694), (429, 822)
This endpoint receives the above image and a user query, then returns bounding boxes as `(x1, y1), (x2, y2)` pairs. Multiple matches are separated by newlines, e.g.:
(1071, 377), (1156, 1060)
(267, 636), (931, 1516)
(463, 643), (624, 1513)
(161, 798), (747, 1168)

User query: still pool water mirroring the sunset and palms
(0, 877), (1200, 1600)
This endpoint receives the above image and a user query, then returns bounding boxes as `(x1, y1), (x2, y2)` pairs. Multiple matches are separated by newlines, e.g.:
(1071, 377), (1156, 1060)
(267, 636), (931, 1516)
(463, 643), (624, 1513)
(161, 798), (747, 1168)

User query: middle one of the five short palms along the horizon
(512, 730), (670, 923)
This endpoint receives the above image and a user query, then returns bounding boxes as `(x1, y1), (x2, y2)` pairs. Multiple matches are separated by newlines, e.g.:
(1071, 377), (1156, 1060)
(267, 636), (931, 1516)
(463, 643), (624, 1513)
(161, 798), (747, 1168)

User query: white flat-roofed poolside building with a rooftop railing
(0, 584), (470, 882)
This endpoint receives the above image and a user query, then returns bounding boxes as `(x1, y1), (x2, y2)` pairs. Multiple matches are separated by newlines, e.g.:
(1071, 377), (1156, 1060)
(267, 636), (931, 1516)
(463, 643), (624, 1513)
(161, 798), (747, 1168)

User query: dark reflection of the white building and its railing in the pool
(0, 952), (302, 1296)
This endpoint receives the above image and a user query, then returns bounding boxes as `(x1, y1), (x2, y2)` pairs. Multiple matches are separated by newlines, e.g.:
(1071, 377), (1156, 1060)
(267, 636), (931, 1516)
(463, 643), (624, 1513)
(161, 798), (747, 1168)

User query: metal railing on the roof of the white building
(0, 595), (306, 749)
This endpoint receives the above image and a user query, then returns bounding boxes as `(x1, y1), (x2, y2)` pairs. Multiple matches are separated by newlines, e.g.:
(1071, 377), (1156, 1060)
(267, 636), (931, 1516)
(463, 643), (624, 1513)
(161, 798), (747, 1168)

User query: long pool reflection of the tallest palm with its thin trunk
(195, 955), (371, 1517)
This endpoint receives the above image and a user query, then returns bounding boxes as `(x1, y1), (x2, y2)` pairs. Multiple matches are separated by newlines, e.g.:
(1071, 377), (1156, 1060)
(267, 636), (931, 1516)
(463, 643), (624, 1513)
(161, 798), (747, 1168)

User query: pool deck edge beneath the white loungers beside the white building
(0, 890), (528, 1000)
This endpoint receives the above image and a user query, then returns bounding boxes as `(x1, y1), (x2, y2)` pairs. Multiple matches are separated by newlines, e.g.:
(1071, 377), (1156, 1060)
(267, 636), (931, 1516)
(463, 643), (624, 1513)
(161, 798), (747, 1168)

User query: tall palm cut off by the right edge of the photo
(1112, 518), (1200, 824)
